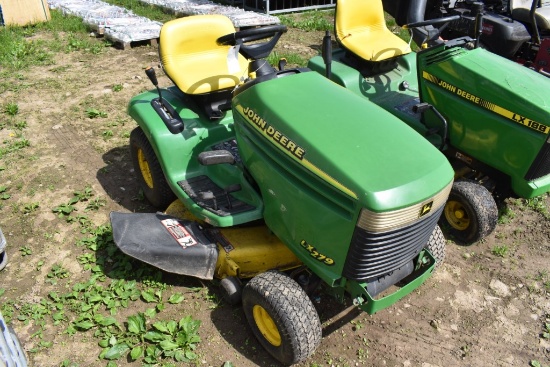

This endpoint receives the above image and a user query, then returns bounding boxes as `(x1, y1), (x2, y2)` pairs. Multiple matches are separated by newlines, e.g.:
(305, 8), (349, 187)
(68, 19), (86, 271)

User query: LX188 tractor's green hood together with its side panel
(418, 47), (550, 198)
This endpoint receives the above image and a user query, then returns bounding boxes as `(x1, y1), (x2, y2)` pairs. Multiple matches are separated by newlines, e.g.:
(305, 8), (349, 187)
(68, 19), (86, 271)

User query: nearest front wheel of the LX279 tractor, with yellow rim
(242, 271), (321, 365)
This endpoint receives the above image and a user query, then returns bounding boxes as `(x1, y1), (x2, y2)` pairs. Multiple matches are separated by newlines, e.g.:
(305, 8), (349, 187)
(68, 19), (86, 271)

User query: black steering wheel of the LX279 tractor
(217, 25), (287, 60)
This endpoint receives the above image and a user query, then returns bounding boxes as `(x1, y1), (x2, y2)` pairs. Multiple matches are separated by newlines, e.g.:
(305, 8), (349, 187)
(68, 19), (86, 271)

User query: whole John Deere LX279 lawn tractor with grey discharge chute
(111, 15), (454, 364)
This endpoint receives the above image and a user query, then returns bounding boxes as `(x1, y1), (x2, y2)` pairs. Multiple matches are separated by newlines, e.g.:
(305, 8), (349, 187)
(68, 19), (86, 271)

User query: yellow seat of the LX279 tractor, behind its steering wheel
(159, 15), (248, 94)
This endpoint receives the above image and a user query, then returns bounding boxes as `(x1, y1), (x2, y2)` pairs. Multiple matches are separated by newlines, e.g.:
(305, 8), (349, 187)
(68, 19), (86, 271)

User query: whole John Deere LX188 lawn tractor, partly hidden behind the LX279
(308, 0), (550, 244)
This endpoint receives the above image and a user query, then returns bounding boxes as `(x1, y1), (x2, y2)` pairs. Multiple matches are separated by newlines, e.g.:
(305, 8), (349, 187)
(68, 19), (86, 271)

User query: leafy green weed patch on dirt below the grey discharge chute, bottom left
(0, 186), (207, 366)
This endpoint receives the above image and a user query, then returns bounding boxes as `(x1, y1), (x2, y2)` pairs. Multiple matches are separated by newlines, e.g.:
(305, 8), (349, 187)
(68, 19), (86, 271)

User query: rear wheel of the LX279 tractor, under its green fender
(130, 127), (176, 209)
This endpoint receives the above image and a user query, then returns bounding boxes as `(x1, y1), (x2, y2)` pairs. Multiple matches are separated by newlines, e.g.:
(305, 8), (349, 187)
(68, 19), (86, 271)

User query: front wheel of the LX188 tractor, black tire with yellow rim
(441, 180), (498, 244)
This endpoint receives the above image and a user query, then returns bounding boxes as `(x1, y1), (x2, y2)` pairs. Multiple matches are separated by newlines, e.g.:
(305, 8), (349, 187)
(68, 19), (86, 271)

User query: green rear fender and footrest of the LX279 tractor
(128, 88), (263, 227)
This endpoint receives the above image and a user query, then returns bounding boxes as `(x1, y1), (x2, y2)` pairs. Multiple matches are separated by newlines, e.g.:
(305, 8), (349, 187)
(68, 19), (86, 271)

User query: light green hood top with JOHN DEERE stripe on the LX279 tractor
(233, 72), (453, 211)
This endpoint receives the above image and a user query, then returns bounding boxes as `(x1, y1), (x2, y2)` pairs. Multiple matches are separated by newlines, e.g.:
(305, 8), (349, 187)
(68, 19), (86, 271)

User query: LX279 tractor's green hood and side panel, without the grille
(233, 73), (453, 285)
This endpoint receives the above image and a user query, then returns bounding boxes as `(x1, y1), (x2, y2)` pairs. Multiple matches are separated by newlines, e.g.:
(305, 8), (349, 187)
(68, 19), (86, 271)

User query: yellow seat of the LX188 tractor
(334, 0), (411, 61)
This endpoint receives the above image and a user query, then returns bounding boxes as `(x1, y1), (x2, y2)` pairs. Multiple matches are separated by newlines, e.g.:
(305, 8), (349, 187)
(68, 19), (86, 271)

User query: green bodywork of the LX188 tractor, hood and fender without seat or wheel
(308, 45), (550, 198)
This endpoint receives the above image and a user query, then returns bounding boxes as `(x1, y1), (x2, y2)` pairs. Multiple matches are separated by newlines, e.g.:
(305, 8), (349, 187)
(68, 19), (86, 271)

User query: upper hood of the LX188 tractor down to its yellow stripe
(419, 47), (550, 134)
